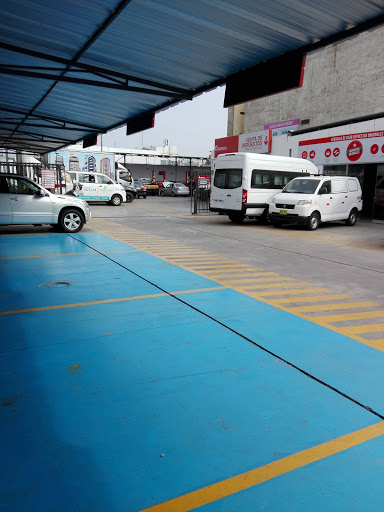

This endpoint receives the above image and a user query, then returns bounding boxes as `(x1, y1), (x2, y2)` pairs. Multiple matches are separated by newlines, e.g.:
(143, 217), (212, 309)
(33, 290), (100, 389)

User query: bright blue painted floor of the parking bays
(0, 233), (384, 512)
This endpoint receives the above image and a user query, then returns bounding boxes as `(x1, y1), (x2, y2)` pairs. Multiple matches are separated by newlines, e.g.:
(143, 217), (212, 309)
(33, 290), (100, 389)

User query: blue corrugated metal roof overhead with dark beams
(0, 0), (384, 152)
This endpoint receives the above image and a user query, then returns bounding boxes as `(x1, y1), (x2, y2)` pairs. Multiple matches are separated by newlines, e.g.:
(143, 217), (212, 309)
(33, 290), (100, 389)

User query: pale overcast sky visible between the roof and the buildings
(98, 86), (227, 158)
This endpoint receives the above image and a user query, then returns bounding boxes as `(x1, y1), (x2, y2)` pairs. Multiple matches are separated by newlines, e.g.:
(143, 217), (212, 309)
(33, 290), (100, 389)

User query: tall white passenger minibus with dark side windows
(209, 153), (319, 222)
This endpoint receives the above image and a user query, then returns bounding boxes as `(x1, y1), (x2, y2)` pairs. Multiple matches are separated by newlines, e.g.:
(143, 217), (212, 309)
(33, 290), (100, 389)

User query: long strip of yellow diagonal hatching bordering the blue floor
(86, 220), (384, 351)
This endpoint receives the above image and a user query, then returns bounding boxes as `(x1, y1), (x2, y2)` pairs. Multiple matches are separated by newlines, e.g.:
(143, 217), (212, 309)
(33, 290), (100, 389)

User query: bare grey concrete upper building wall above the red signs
(240, 27), (384, 134)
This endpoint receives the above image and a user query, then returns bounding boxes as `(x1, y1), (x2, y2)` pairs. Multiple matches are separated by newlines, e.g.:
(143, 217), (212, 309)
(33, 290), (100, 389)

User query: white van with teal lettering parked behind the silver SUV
(69, 171), (126, 206)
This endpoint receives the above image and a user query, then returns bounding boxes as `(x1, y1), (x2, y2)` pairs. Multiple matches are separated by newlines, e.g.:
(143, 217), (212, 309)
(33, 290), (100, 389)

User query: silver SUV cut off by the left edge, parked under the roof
(0, 174), (91, 233)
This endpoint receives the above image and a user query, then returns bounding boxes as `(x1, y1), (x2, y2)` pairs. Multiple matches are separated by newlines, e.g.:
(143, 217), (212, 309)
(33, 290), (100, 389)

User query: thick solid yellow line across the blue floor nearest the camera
(140, 421), (384, 512)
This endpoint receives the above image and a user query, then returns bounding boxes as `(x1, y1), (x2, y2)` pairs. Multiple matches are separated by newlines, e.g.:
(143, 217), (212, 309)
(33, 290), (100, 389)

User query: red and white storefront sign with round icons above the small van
(298, 131), (384, 165)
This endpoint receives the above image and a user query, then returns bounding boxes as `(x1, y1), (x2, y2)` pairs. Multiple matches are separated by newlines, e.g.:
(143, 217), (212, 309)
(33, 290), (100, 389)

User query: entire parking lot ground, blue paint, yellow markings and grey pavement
(0, 196), (384, 512)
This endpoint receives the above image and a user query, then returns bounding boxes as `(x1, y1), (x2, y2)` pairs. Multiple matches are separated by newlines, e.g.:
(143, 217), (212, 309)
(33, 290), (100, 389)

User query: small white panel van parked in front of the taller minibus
(269, 176), (363, 230)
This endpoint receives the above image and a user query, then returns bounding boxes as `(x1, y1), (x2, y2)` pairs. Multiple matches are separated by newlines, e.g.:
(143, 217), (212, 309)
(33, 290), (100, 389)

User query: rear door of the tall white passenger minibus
(211, 168), (243, 211)
